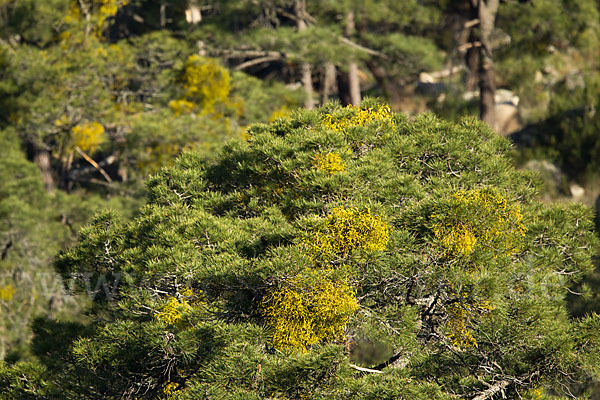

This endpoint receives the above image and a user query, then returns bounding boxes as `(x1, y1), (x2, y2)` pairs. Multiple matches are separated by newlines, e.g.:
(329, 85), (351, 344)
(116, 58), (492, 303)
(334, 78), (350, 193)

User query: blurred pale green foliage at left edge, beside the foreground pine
(0, 130), (126, 360)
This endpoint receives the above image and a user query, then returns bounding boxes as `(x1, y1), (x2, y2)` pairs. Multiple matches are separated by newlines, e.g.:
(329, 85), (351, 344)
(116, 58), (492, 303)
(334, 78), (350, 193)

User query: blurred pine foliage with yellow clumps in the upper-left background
(0, 0), (297, 190)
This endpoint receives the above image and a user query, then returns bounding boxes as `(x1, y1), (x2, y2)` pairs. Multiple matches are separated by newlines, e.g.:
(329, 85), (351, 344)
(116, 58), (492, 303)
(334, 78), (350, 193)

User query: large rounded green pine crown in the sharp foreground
(0, 100), (598, 399)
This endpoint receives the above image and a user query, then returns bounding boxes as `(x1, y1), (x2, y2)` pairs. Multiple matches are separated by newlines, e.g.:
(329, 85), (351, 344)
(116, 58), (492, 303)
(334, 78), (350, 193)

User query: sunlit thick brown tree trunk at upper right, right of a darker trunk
(477, 0), (500, 129)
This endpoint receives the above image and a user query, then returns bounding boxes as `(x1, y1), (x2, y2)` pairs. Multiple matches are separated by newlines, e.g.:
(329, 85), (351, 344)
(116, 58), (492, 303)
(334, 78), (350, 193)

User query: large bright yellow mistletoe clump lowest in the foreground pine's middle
(263, 271), (358, 352)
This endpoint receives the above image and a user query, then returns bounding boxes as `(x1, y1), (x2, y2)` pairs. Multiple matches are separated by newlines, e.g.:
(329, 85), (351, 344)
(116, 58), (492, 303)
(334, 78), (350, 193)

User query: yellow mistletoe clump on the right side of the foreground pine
(431, 189), (527, 256)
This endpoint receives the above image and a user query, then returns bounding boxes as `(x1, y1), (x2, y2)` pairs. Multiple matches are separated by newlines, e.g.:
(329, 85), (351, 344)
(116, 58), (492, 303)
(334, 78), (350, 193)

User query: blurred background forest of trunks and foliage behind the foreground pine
(0, 0), (600, 361)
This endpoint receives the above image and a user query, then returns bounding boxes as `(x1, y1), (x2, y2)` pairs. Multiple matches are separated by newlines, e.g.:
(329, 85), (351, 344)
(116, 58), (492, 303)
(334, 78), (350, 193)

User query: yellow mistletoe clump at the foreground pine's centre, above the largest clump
(304, 207), (390, 261)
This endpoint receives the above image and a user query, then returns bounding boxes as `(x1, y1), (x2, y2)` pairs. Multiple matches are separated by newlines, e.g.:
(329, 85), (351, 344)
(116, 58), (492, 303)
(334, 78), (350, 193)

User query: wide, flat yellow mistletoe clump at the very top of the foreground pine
(322, 105), (396, 133)
